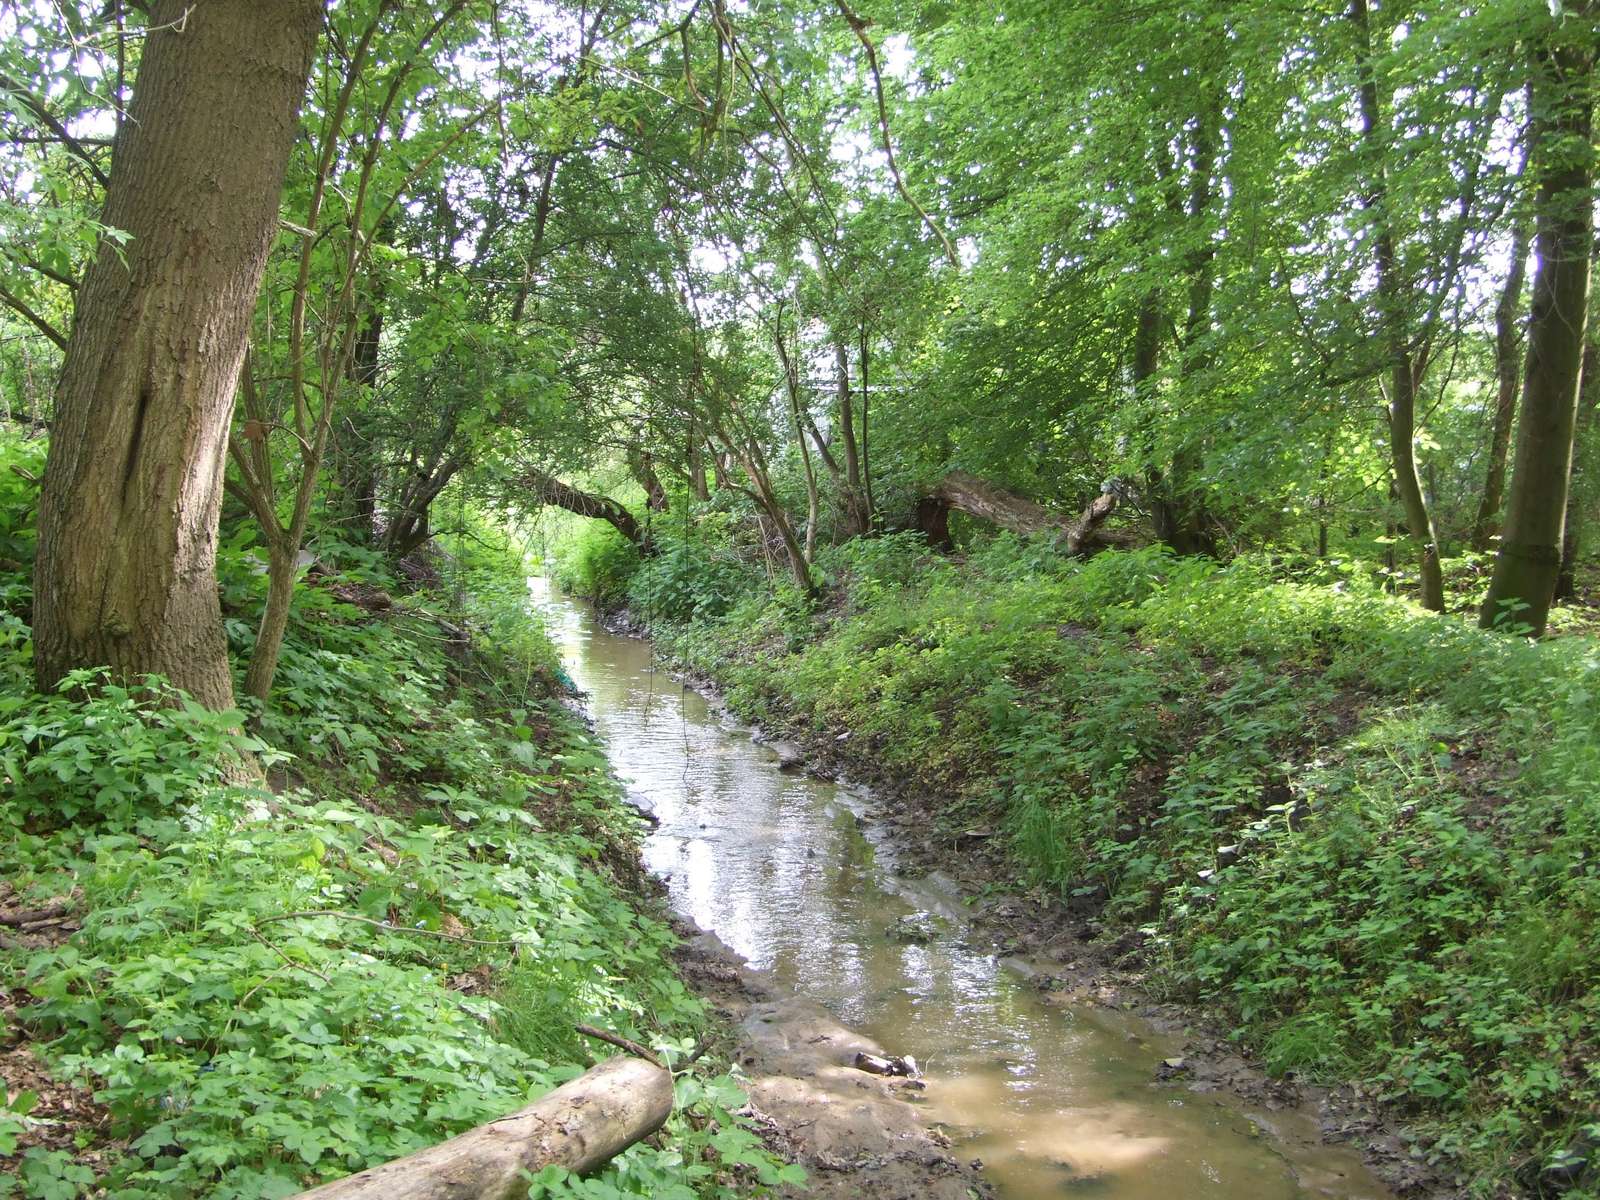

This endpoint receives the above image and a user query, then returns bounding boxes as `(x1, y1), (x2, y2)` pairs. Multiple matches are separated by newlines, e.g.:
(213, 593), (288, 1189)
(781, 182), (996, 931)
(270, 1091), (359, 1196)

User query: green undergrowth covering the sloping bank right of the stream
(588, 536), (1600, 1195)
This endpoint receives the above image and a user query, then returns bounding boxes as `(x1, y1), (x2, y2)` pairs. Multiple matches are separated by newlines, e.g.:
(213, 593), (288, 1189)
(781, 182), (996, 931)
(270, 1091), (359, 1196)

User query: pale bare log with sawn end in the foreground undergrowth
(296, 1056), (672, 1200)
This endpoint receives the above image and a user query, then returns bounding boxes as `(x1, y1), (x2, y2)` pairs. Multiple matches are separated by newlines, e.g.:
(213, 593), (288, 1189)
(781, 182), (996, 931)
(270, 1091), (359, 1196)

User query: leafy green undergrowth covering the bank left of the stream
(0, 448), (795, 1200)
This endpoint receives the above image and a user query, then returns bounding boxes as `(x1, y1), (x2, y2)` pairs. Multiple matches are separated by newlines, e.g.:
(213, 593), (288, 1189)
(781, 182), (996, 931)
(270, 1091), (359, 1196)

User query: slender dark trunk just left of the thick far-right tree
(1350, 0), (1445, 613)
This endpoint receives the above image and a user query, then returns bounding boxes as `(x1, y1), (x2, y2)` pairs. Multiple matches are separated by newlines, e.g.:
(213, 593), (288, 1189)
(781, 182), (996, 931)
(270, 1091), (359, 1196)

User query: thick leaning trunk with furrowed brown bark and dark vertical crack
(34, 0), (322, 709)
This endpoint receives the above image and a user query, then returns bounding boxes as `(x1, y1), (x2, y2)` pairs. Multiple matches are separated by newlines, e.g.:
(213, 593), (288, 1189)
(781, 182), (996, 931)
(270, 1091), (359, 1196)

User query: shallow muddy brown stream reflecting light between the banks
(533, 579), (1392, 1200)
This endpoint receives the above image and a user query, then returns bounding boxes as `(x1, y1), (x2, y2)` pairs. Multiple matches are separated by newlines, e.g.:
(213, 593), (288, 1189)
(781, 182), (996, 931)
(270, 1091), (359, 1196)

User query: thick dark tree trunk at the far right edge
(1480, 28), (1594, 637)
